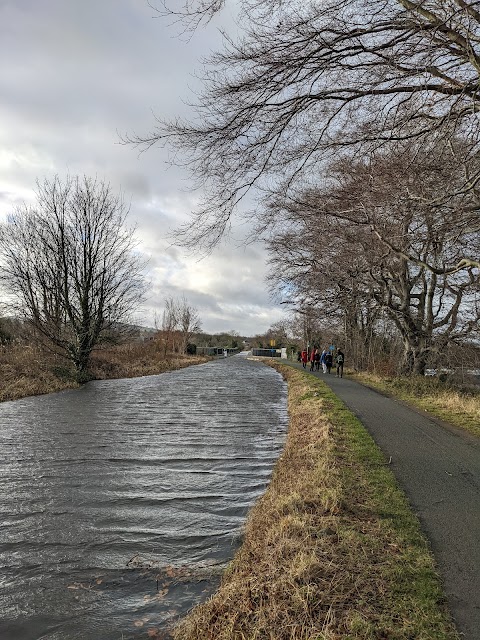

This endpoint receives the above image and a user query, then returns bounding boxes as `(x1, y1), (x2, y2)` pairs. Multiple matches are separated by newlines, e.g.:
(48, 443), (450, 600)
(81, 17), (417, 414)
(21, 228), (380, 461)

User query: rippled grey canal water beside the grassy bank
(0, 356), (287, 640)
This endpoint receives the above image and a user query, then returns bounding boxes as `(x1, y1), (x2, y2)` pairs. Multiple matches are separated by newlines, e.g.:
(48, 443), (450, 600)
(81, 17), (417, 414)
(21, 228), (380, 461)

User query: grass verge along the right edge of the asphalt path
(351, 372), (480, 436)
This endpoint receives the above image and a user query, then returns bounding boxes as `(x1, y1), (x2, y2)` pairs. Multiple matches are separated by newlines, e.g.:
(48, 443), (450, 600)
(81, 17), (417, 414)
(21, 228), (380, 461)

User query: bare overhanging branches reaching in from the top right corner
(138, 0), (480, 268)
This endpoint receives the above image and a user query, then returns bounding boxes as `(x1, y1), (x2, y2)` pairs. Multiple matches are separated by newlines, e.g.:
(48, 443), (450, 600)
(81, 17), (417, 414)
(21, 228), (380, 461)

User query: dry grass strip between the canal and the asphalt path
(174, 365), (458, 640)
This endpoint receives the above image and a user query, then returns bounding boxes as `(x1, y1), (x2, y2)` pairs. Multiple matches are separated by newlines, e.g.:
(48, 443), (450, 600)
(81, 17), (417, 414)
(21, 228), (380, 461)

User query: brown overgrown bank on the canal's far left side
(0, 341), (209, 401)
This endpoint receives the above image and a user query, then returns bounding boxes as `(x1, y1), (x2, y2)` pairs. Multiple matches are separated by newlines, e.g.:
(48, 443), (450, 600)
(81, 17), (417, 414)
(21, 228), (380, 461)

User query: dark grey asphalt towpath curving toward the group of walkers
(288, 365), (480, 640)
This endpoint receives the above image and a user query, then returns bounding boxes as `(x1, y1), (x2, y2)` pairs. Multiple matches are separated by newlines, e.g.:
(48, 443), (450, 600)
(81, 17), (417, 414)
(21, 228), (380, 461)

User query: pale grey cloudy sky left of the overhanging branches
(0, 0), (283, 335)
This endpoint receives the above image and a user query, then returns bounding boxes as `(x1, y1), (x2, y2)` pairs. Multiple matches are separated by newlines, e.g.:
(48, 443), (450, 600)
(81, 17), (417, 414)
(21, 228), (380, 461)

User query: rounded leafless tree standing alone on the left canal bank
(0, 177), (145, 379)
